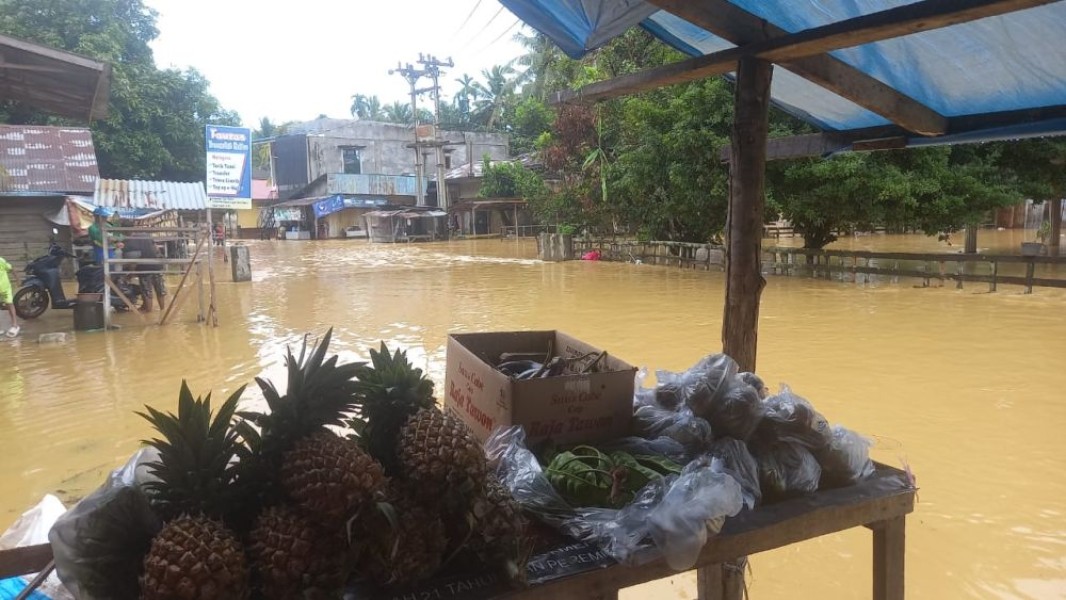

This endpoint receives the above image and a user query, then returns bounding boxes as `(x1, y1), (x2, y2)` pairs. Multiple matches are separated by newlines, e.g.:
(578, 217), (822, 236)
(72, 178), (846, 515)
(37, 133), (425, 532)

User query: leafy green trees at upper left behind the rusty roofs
(0, 0), (240, 181)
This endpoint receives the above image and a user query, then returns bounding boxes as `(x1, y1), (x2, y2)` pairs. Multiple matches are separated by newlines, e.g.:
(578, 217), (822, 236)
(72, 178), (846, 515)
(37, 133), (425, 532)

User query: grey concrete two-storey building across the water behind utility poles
(262, 119), (510, 239)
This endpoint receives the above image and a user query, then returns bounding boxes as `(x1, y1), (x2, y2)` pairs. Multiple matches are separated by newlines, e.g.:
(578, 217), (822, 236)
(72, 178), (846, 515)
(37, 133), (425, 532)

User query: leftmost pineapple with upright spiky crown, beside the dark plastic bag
(139, 382), (249, 600)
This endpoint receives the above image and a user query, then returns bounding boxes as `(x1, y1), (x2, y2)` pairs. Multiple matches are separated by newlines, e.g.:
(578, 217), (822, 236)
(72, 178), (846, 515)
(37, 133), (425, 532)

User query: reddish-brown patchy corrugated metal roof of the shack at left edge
(0, 125), (100, 194)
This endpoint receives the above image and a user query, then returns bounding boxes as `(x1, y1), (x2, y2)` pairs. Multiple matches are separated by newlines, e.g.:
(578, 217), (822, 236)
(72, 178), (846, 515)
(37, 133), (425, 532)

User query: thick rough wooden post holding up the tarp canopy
(722, 58), (774, 372)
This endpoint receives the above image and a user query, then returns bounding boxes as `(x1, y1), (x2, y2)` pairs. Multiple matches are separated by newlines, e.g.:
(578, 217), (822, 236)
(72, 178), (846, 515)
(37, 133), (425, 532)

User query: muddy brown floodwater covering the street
(0, 238), (1066, 600)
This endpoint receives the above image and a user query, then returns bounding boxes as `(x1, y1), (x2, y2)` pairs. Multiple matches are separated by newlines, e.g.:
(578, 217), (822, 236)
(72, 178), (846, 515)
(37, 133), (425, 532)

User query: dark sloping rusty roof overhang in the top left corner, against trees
(0, 35), (111, 120)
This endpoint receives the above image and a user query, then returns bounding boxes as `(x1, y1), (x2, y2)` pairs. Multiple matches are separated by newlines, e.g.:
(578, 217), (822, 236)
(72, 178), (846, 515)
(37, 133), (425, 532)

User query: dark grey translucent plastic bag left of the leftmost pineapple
(48, 448), (163, 600)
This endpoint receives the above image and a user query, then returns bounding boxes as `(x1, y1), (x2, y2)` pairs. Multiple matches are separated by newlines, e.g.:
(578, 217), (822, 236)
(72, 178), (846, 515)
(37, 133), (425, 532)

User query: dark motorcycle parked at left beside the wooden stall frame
(12, 241), (141, 319)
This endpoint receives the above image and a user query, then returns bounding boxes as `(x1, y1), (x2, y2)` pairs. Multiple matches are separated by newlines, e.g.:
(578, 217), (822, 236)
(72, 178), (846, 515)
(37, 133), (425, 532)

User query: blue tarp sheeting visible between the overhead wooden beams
(501, 0), (1066, 134)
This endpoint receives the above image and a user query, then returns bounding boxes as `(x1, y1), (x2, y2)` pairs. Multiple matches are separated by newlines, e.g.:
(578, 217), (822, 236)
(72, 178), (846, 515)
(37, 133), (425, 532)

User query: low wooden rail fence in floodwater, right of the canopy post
(762, 247), (1066, 294)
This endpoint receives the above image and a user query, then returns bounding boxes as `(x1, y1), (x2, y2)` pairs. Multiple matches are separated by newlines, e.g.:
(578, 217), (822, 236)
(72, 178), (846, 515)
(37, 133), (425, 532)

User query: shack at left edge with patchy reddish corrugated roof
(0, 125), (99, 273)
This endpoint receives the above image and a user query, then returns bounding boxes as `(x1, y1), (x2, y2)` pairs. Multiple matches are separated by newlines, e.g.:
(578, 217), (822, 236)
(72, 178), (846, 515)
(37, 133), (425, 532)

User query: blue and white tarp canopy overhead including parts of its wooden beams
(501, 0), (1066, 143)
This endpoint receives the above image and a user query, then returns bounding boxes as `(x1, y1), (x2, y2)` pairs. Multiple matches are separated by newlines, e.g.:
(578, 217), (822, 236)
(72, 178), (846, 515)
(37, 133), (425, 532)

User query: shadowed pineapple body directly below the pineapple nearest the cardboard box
(354, 489), (448, 585)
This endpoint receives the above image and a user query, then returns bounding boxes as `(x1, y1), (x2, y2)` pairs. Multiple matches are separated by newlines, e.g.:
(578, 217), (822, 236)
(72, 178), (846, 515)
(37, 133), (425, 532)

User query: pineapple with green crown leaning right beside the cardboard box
(353, 342), (488, 503)
